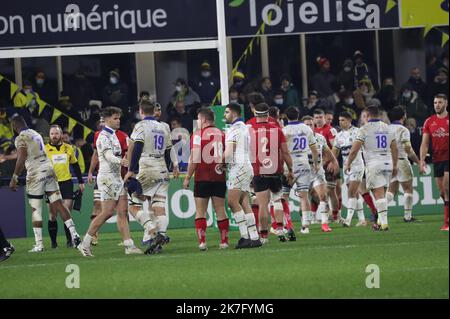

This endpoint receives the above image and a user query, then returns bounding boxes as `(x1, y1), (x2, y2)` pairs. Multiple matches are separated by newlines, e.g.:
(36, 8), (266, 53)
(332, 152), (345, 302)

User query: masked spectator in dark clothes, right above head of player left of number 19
(103, 69), (129, 112)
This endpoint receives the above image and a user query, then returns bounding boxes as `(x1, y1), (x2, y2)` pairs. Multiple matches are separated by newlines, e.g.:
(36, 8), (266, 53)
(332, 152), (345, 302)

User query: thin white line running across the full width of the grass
(0, 240), (448, 269)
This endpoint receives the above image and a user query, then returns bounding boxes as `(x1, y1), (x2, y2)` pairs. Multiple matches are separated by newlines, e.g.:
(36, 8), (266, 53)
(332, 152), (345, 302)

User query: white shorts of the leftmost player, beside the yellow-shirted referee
(26, 166), (59, 196)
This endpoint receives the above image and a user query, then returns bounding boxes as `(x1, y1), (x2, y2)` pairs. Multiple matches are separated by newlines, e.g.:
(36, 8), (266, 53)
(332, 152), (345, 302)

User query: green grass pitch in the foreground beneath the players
(0, 216), (449, 299)
